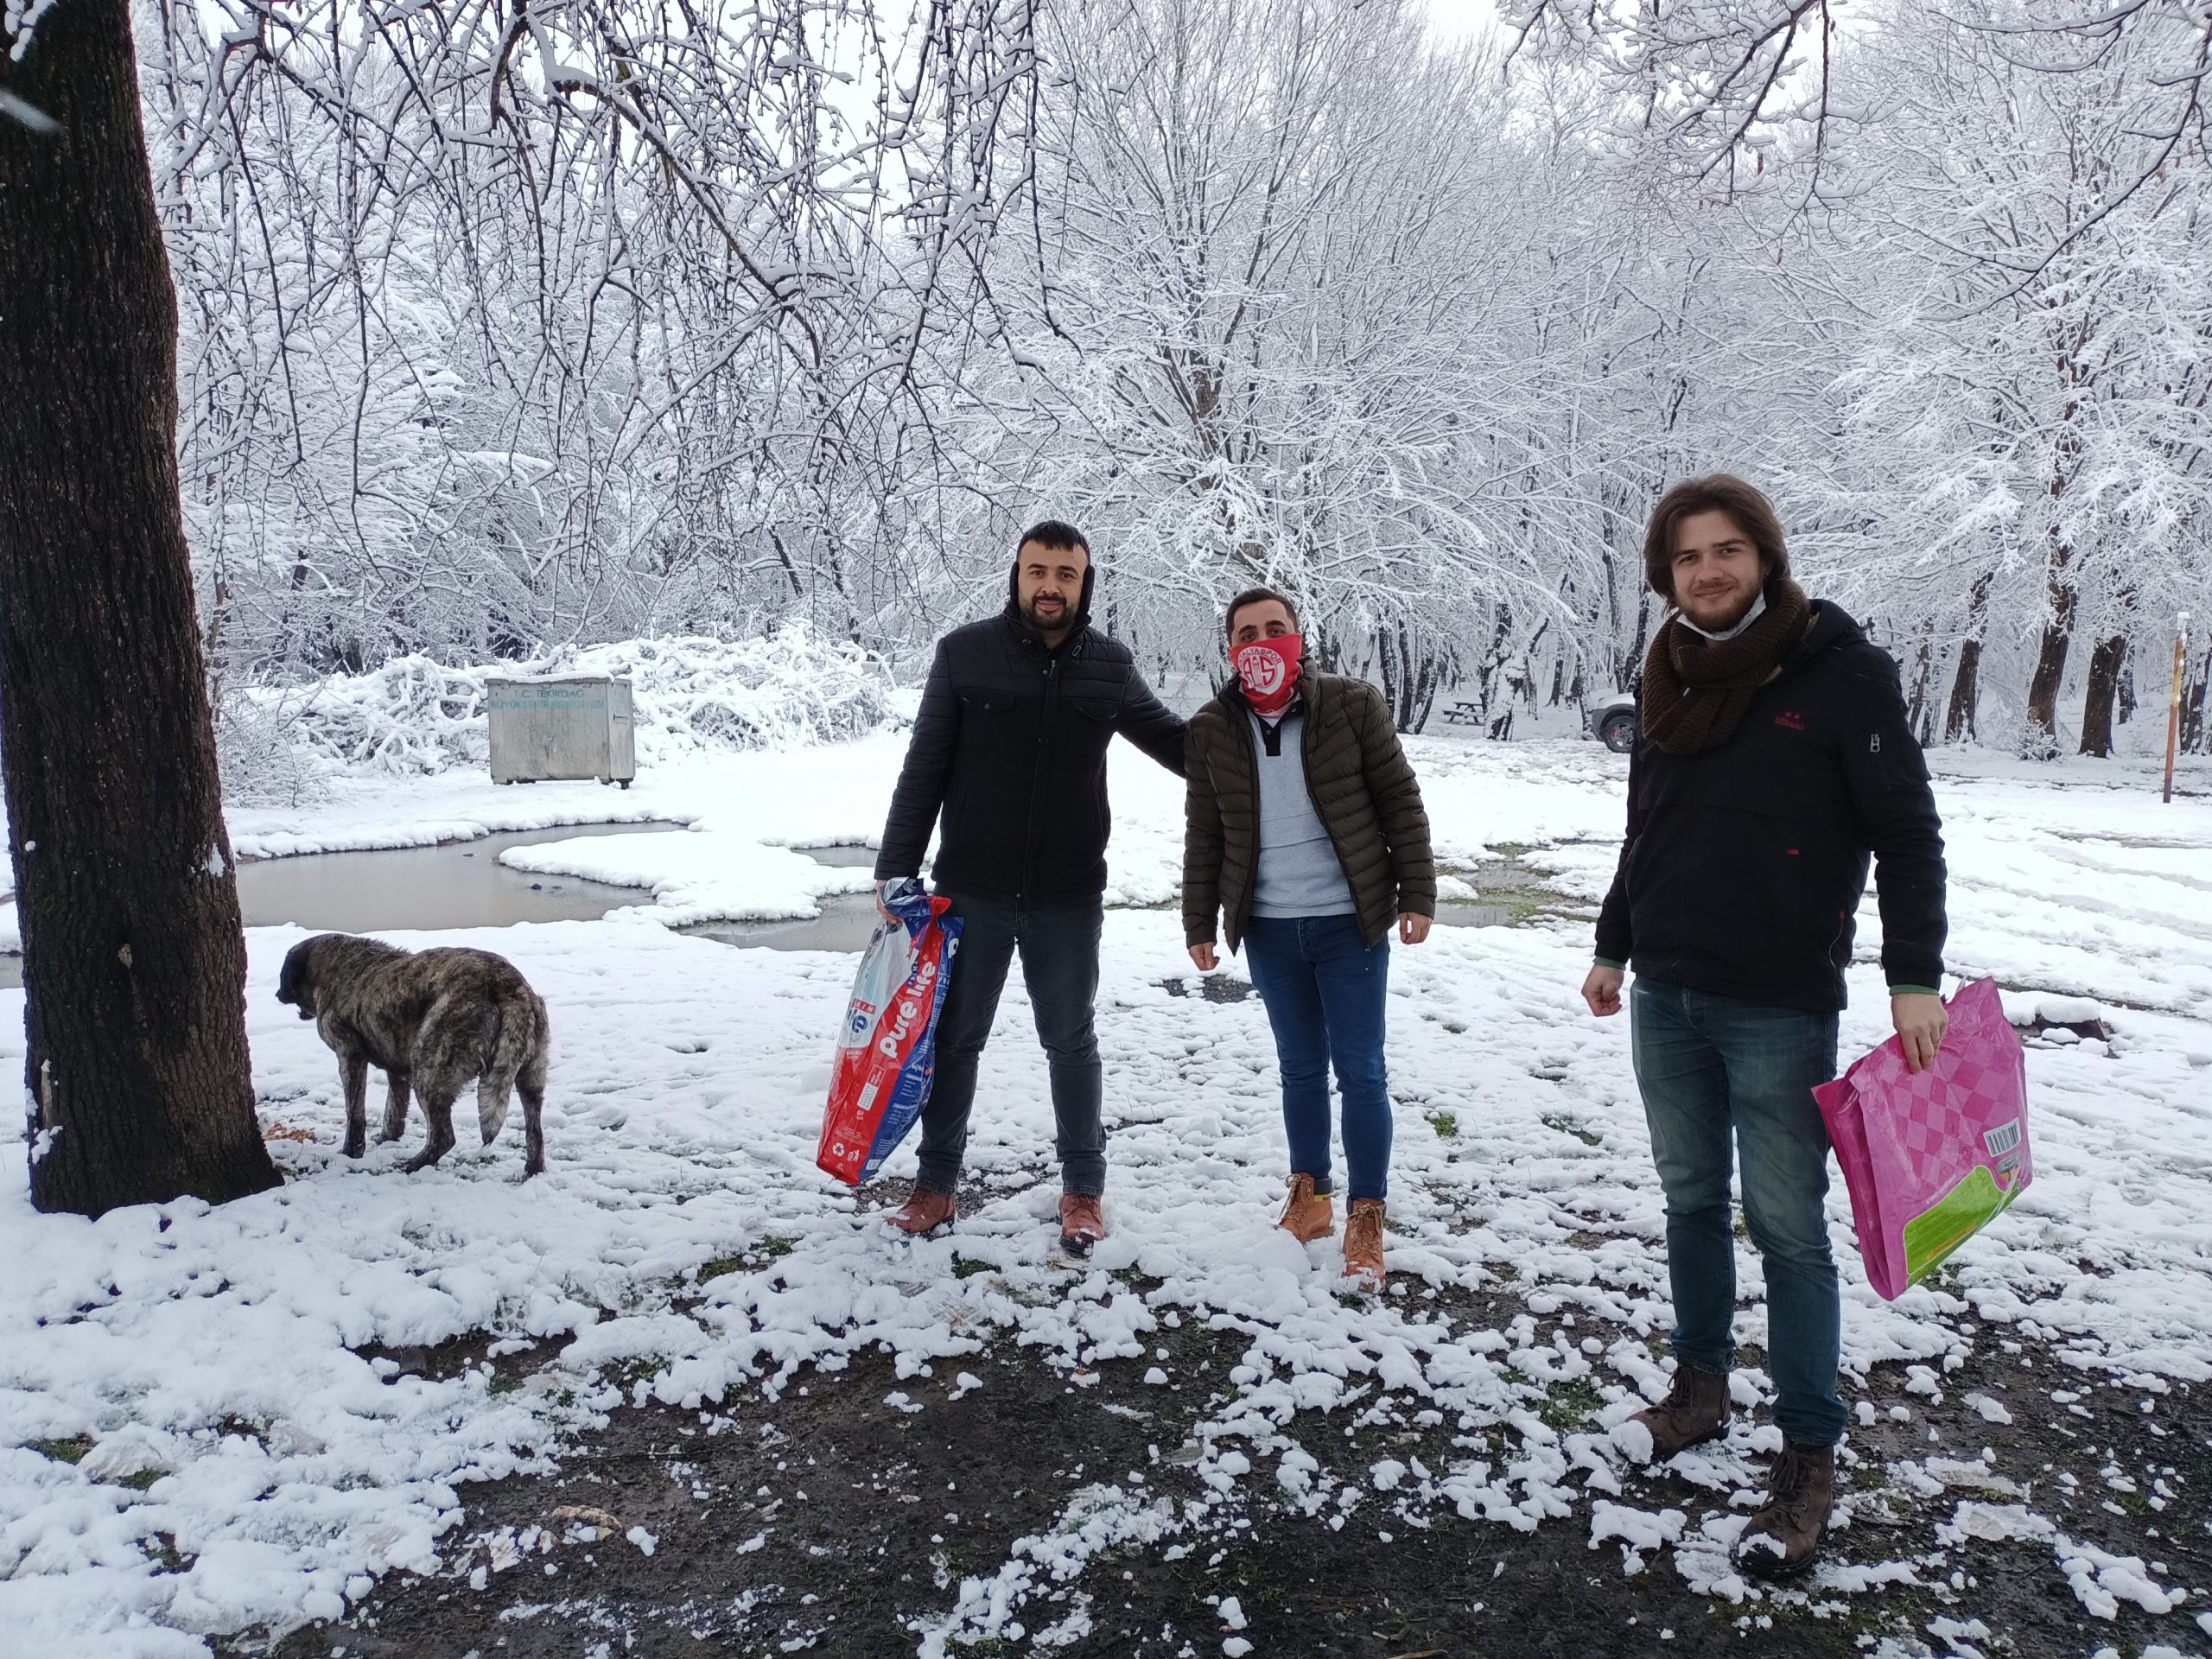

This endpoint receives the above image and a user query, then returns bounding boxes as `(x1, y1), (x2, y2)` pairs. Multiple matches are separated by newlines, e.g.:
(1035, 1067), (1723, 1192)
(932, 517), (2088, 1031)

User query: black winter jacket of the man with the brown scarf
(1597, 601), (1944, 1013)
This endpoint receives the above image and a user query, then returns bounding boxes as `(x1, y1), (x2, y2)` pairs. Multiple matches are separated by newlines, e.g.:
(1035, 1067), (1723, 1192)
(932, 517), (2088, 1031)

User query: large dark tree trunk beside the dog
(0, 0), (276, 1214)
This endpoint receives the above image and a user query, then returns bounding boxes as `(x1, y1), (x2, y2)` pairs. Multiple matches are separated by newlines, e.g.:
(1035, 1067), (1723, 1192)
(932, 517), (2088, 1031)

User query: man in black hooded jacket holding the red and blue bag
(876, 520), (1184, 1255)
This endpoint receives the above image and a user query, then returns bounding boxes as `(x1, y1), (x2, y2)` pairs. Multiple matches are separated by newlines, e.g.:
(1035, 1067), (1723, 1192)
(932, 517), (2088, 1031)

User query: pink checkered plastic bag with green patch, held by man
(1812, 980), (2035, 1300)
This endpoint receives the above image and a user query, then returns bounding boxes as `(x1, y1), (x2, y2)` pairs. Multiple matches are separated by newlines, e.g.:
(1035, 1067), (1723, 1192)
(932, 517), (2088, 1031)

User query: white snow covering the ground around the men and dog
(0, 736), (2212, 1655)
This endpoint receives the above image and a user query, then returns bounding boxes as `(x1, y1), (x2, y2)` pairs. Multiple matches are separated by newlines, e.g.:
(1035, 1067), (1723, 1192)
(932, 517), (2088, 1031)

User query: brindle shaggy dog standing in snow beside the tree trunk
(276, 933), (546, 1177)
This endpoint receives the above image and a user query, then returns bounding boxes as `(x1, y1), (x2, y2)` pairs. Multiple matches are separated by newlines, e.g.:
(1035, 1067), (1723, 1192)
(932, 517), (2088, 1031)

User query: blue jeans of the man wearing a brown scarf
(1628, 976), (1842, 1446)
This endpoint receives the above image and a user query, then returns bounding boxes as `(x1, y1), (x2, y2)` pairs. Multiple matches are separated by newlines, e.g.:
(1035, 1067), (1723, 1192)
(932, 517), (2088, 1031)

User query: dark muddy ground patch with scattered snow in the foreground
(224, 1211), (2212, 1659)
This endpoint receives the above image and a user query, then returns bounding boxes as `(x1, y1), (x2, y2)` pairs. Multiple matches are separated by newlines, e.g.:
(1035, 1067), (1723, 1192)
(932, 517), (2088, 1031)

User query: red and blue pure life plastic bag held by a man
(814, 876), (960, 1185)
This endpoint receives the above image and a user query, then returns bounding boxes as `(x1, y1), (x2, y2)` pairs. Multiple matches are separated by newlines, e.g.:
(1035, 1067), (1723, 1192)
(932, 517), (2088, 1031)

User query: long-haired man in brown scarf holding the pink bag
(1581, 474), (1944, 1575)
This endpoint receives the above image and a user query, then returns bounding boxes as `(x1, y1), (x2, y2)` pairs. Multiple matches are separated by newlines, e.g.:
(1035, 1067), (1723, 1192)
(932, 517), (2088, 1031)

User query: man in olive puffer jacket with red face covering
(1184, 588), (1435, 1287)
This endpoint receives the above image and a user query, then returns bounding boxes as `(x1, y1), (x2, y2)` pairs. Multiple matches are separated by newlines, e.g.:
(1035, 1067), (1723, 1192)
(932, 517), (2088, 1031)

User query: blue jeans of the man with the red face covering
(1245, 916), (1391, 1199)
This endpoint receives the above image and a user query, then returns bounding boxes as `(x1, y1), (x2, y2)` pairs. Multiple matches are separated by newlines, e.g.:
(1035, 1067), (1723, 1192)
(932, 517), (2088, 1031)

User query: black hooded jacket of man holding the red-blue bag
(876, 566), (1184, 907)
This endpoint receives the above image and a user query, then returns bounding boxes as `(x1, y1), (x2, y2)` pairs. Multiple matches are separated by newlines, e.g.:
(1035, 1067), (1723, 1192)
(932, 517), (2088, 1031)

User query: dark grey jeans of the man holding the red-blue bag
(916, 889), (1106, 1197)
